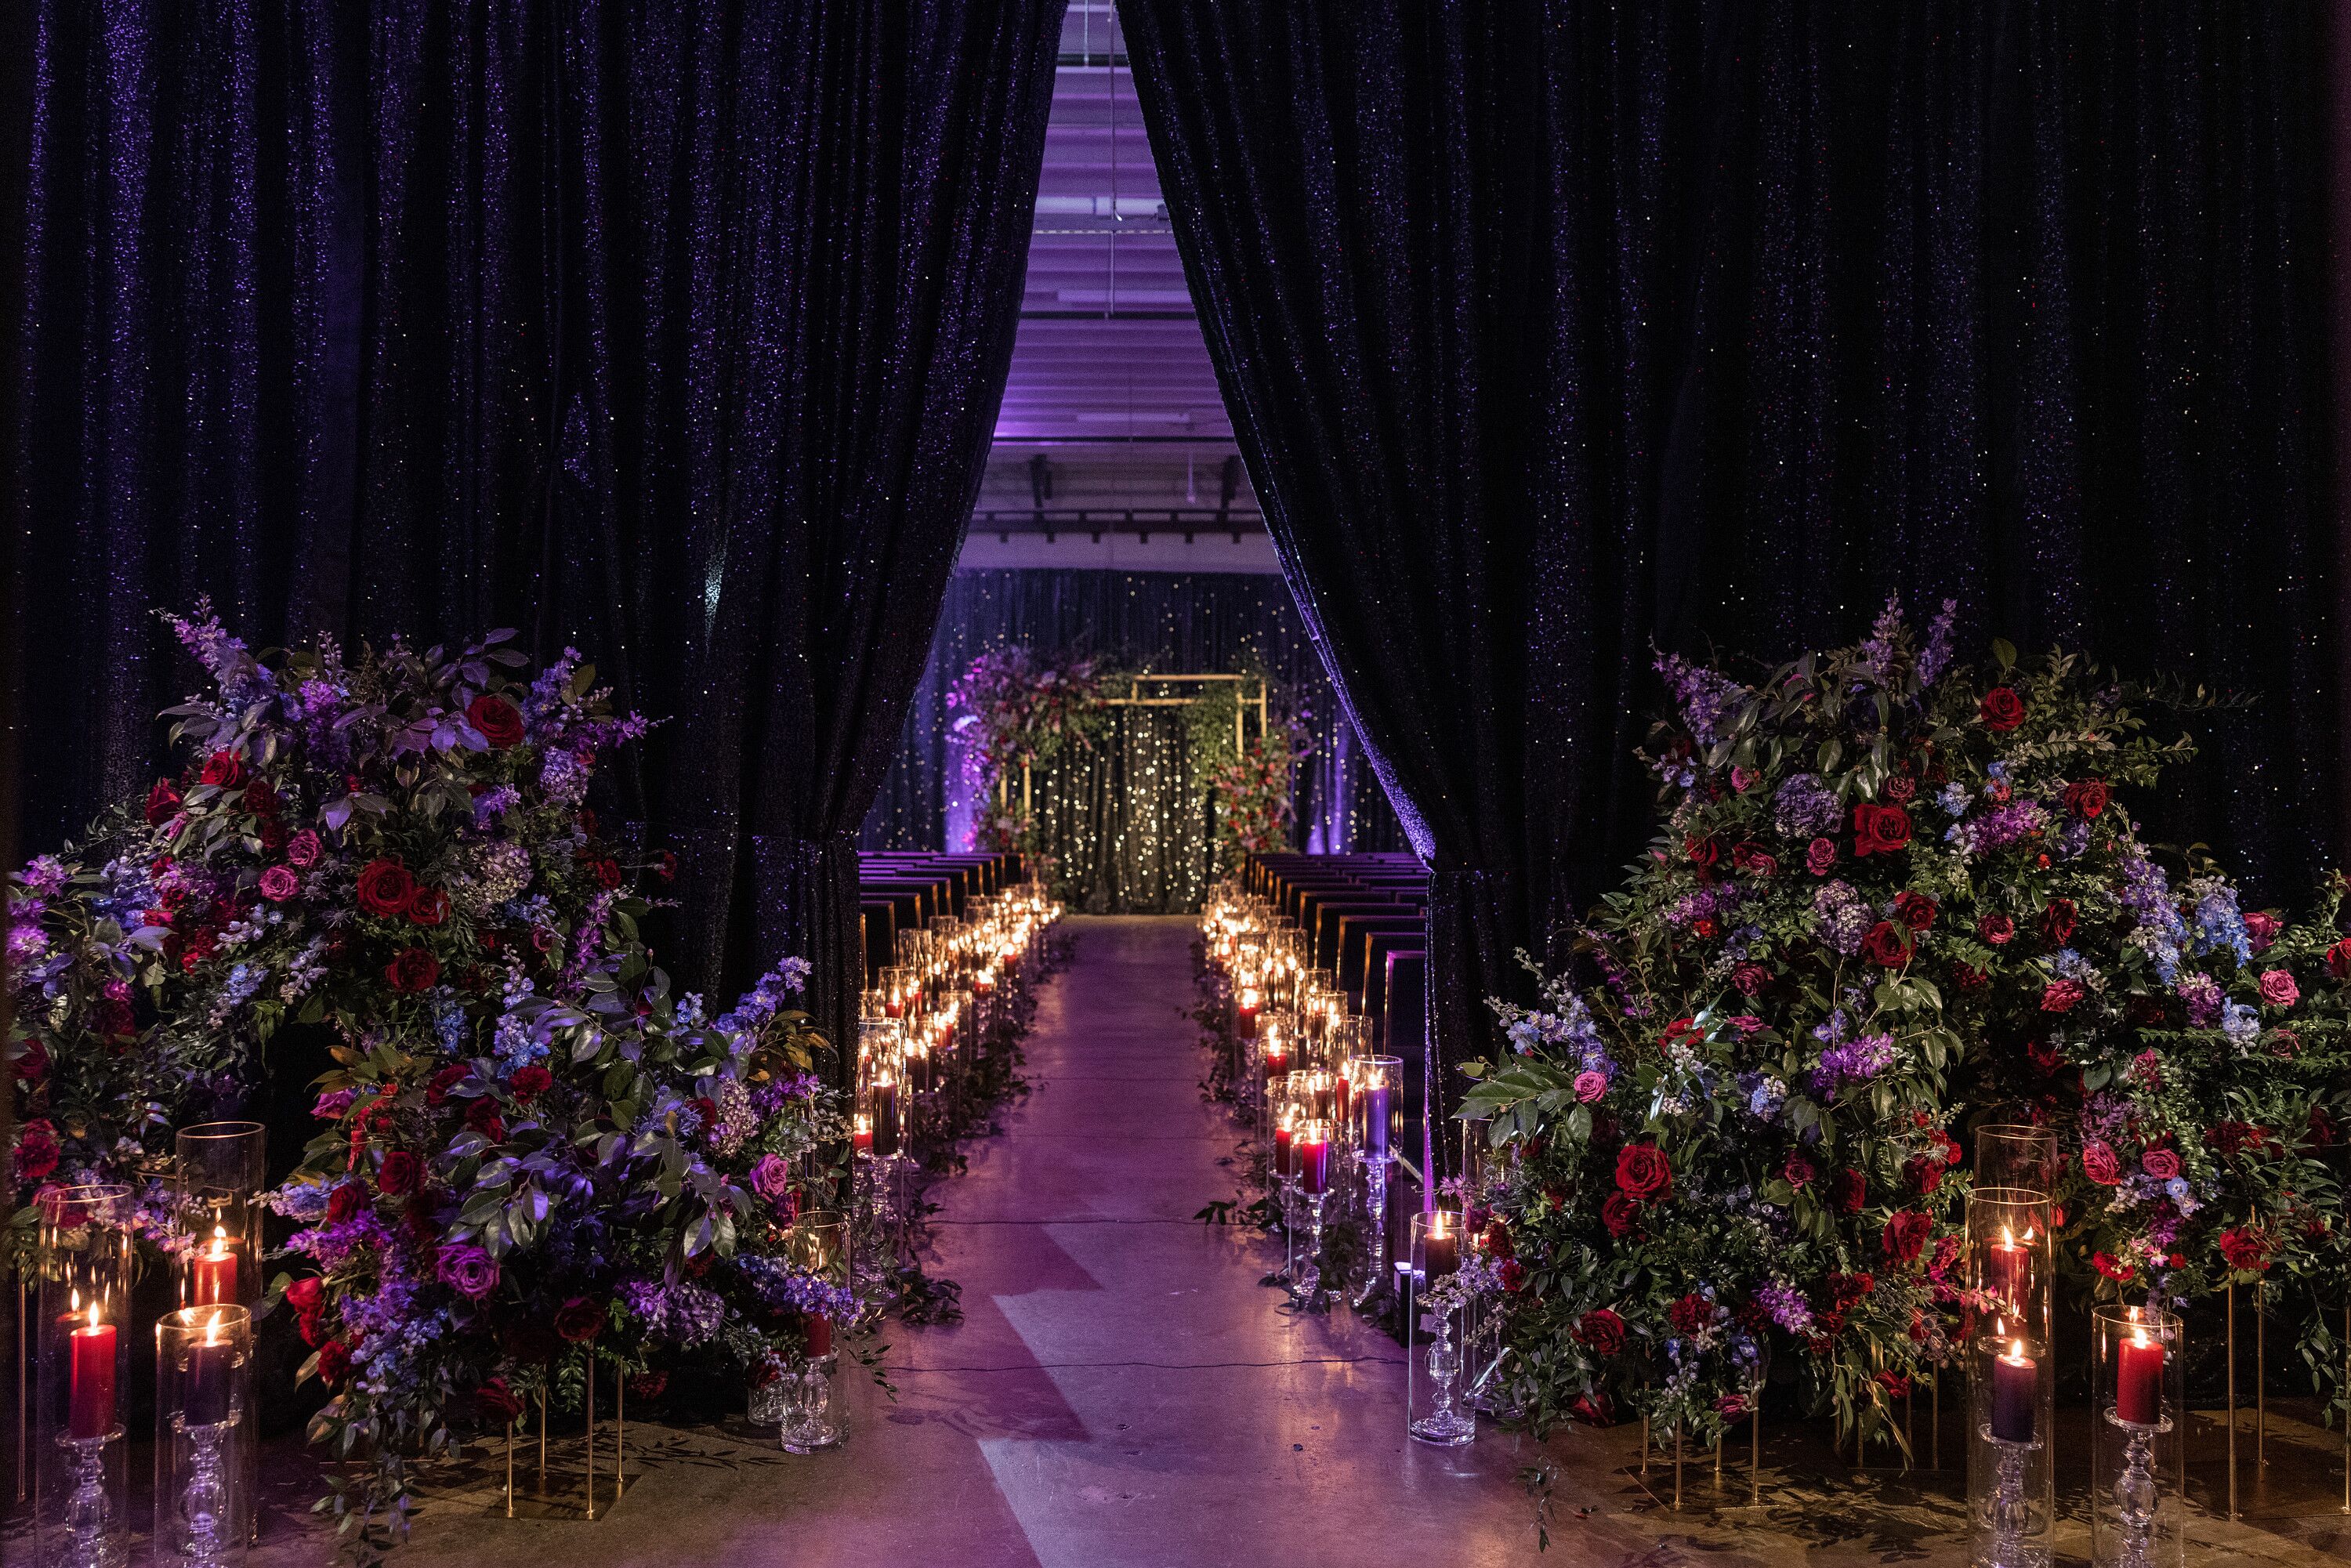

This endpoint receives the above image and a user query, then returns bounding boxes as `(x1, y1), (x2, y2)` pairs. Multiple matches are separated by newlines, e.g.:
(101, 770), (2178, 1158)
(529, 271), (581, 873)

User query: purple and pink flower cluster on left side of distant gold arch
(947, 646), (1107, 853)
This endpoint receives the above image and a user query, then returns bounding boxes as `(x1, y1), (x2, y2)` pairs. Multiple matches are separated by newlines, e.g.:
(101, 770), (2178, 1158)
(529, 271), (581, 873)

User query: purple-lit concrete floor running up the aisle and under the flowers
(216, 917), (2351, 1568)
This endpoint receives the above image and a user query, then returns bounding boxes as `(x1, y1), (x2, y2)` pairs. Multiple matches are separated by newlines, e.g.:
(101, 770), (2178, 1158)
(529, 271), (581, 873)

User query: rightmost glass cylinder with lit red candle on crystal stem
(2090, 1305), (2189, 1568)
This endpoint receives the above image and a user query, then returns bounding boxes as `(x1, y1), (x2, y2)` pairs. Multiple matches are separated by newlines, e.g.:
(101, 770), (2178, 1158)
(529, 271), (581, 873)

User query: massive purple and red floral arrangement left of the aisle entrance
(9, 618), (858, 1554)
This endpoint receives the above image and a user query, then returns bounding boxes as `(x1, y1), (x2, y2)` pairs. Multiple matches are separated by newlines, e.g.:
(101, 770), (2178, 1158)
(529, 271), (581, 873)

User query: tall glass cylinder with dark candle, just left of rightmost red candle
(1968, 1187), (2057, 1568)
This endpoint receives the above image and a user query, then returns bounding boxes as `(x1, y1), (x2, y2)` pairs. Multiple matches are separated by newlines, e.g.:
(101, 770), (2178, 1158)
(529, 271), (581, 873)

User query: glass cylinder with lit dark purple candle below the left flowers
(155, 1302), (256, 1568)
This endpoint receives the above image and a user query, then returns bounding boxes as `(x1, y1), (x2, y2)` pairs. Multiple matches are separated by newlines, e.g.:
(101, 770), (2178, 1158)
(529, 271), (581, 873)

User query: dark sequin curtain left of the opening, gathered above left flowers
(12, 0), (1060, 1063)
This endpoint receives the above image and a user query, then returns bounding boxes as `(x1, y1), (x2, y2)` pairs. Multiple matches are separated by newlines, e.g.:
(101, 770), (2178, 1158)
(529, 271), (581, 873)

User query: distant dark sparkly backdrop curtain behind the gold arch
(863, 567), (1404, 879)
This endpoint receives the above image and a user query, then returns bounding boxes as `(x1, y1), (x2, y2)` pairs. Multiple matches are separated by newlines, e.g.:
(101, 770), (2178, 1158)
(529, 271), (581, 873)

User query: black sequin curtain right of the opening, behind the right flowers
(1121, 0), (2339, 1166)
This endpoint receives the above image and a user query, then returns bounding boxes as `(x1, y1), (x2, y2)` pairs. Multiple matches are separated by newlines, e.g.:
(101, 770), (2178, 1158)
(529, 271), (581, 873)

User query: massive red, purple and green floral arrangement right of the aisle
(1462, 604), (2351, 1441)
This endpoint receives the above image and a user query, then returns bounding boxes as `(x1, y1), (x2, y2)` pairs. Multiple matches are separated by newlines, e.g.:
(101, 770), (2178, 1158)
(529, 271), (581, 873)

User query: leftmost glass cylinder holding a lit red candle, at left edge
(28, 1185), (136, 1568)
